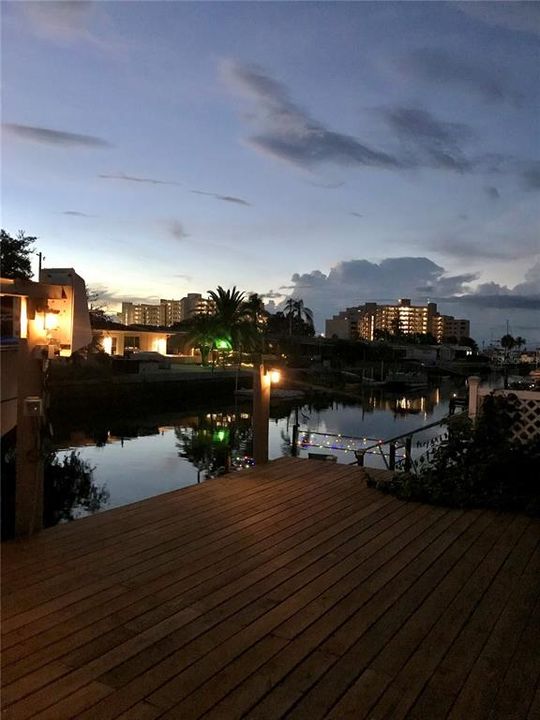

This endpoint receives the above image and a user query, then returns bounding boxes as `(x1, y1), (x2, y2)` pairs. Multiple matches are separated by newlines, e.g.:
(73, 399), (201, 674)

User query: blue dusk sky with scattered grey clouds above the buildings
(1, 0), (540, 346)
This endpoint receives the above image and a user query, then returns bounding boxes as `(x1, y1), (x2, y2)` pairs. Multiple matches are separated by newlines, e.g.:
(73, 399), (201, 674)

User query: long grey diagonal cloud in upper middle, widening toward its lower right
(222, 60), (399, 168)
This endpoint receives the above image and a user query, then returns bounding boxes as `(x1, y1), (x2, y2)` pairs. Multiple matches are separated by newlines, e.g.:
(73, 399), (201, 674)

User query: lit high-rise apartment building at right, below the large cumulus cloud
(326, 298), (469, 342)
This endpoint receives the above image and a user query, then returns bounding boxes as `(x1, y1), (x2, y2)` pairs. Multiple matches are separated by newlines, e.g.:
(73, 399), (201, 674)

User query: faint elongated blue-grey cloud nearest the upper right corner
(400, 48), (522, 104)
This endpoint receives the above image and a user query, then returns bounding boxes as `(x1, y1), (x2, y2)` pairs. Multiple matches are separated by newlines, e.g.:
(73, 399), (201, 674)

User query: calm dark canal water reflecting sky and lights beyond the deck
(47, 380), (465, 524)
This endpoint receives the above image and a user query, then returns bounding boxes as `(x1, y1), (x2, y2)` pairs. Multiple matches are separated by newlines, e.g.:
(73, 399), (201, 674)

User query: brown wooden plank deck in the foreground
(2, 458), (540, 720)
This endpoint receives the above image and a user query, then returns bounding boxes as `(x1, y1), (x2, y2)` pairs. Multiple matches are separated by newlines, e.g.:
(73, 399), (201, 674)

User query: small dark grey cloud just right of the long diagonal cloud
(379, 106), (473, 172)
